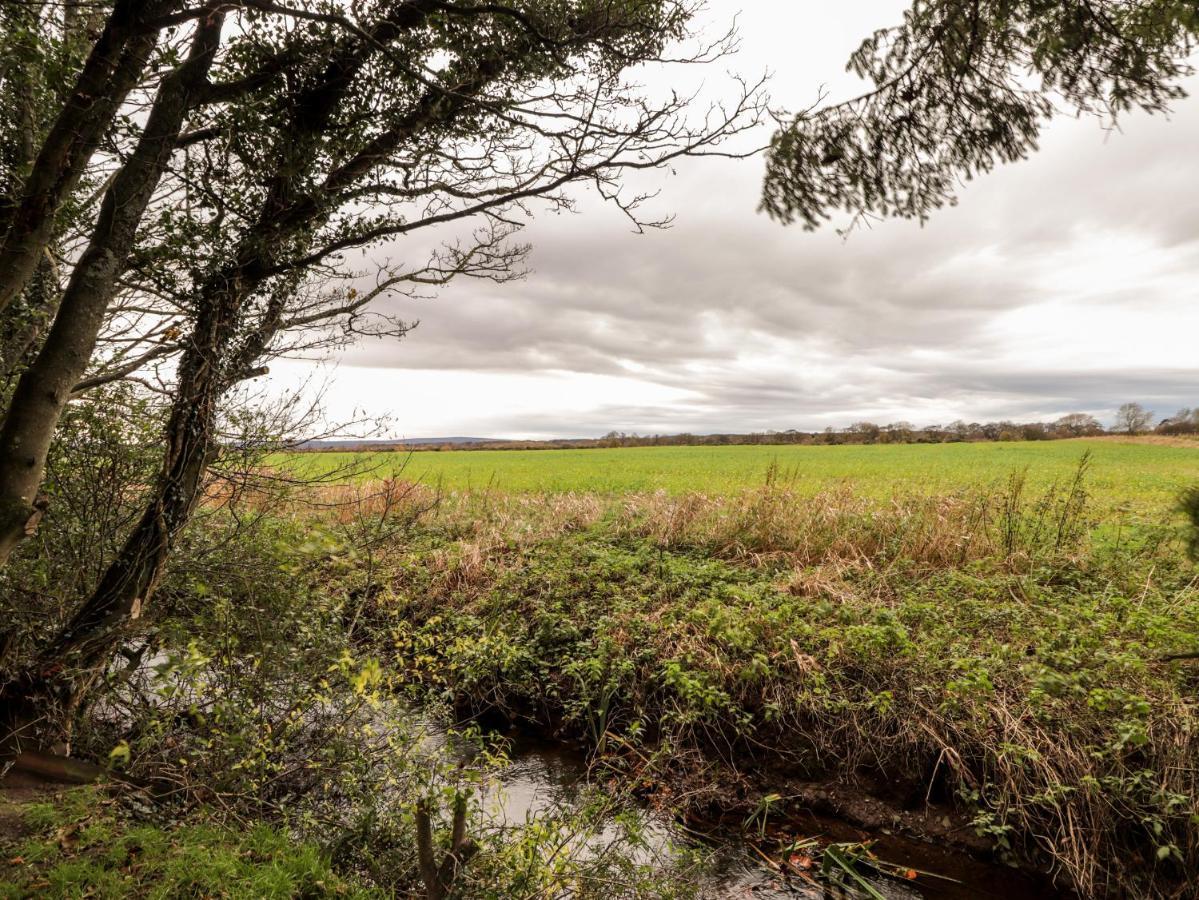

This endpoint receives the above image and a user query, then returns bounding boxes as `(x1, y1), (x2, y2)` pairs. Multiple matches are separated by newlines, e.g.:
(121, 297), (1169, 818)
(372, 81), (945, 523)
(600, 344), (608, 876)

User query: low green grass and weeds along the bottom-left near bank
(0, 785), (701, 900)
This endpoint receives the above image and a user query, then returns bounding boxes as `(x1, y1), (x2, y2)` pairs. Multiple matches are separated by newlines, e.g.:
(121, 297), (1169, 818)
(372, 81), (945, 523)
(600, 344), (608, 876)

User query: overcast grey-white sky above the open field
(262, 0), (1199, 439)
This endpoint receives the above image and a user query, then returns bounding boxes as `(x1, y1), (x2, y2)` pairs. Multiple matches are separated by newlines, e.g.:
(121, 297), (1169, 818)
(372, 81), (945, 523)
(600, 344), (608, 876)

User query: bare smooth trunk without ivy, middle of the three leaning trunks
(0, 13), (223, 566)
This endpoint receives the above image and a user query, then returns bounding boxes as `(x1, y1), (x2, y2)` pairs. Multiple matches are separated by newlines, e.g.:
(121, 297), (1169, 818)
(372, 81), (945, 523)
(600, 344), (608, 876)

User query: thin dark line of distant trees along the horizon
(305, 404), (1199, 452)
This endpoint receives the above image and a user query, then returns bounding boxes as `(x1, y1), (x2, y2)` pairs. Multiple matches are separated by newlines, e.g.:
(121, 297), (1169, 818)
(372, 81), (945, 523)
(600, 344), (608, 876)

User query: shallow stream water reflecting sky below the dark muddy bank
(426, 719), (1072, 900)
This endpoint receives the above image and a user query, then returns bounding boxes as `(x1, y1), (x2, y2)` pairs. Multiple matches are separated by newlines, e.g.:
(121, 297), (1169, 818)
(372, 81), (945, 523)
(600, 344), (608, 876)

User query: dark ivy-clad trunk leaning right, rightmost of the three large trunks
(0, 5), (448, 741)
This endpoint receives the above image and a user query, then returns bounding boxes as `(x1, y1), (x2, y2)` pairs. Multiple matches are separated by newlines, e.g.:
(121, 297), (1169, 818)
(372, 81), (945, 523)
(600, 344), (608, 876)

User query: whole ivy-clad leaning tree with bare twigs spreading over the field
(0, 0), (759, 738)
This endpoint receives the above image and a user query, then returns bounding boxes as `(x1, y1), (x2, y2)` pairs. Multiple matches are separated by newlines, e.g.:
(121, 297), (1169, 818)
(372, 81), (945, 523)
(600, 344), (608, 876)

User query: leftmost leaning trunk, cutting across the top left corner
(0, 0), (176, 312)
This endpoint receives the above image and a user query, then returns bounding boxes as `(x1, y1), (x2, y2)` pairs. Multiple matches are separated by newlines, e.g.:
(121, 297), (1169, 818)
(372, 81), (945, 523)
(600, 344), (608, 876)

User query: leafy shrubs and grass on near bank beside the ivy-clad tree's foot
(0, 460), (700, 898)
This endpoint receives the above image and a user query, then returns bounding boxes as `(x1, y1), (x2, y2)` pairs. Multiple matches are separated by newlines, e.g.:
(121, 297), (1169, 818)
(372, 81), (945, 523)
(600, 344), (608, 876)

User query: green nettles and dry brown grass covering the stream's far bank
(342, 478), (1199, 895)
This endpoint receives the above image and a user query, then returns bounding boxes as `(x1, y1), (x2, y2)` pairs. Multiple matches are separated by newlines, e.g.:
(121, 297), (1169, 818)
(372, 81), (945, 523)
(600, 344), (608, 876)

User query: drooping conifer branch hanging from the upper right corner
(761, 0), (1199, 228)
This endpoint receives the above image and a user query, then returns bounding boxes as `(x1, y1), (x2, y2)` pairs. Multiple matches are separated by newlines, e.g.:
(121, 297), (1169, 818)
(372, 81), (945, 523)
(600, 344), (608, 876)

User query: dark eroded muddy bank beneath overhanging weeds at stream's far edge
(459, 707), (1078, 900)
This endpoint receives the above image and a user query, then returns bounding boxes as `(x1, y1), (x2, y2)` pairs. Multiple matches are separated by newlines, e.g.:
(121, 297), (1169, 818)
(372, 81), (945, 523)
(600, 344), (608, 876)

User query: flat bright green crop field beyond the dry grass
(276, 440), (1199, 513)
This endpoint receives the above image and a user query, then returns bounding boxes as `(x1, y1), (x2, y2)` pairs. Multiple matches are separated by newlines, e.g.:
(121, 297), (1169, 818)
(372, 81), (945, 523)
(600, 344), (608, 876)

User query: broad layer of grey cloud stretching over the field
(316, 7), (1199, 434)
